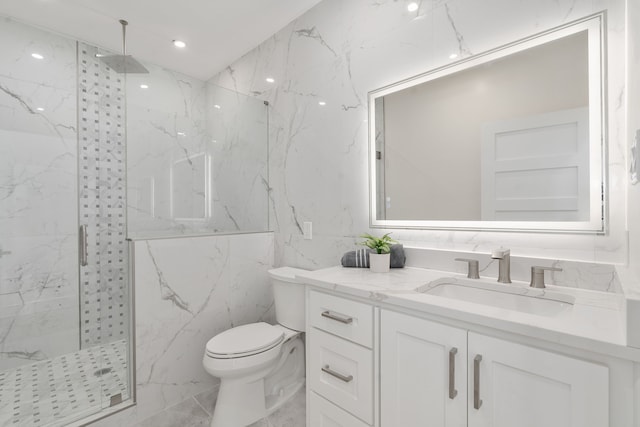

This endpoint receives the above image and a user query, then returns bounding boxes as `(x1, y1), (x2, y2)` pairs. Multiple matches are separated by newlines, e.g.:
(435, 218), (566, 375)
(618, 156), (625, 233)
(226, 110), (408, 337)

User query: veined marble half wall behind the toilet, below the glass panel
(89, 233), (275, 427)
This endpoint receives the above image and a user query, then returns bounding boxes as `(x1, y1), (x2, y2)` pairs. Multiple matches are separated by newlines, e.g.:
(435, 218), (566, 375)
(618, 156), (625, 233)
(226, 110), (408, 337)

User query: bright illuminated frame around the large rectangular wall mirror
(368, 12), (608, 234)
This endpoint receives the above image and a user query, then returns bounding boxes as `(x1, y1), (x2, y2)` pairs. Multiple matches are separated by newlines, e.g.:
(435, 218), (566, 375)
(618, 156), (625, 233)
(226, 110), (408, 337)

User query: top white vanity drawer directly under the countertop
(307, 291), (373, 348)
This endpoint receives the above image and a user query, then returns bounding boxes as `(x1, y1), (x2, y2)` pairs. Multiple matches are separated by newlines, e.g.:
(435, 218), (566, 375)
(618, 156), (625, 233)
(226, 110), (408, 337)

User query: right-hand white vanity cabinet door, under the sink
(468, 332), (609, 427)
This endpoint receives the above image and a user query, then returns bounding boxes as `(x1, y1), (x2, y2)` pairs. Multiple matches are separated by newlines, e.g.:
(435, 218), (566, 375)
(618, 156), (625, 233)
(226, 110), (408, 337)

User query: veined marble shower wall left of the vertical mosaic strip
(0, 18), (79, 370)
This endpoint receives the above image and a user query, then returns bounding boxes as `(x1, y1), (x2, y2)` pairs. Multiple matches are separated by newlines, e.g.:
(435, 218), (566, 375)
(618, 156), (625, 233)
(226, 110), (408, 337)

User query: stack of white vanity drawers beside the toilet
(307, 291), (375, 427)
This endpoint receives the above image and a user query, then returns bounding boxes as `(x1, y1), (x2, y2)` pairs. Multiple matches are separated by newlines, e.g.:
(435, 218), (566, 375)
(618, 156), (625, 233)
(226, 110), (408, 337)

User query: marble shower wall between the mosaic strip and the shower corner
(127, 64), (207, 236)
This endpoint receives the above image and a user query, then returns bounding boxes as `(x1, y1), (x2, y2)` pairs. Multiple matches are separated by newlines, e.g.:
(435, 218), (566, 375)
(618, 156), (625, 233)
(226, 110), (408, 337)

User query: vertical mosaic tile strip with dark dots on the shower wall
(78, 43), (128, 348)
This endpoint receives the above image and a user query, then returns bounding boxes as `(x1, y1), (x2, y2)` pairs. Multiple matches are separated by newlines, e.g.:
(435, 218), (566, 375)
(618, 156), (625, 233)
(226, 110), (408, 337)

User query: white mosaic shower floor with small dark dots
(0, 340), (129, 427)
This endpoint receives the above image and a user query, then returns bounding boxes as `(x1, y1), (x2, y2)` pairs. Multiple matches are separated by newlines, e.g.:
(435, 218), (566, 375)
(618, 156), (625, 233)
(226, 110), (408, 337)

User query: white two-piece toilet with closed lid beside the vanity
(202, 267), (305, 427)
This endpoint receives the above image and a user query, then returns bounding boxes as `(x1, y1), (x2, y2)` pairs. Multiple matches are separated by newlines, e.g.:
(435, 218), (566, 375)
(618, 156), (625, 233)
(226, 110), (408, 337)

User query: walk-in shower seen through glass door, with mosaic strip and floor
(0, 18), (132, 426)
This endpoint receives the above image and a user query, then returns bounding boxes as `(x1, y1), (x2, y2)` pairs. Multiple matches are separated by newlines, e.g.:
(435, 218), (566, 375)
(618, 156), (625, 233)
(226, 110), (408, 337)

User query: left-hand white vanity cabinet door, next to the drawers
(380, 310), (464, 427)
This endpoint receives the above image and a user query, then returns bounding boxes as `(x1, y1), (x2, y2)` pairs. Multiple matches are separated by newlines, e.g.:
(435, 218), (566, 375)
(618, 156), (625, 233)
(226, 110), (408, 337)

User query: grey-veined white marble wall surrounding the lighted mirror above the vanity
(210, 0), (627, 268)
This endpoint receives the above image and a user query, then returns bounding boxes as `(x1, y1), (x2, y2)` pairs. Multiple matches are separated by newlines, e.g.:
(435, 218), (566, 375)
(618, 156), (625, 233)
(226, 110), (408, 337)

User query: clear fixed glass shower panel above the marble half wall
(127, 64), (269, 237)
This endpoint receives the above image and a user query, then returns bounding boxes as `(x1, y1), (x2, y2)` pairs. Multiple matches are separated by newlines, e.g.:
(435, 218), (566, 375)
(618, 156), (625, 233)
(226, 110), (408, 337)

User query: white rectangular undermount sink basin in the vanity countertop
(416, 279), (575, 316)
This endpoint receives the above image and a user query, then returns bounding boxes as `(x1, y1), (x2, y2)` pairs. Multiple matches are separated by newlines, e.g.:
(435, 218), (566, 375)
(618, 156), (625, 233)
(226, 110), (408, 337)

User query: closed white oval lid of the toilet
(207, 322), (284, 359)
